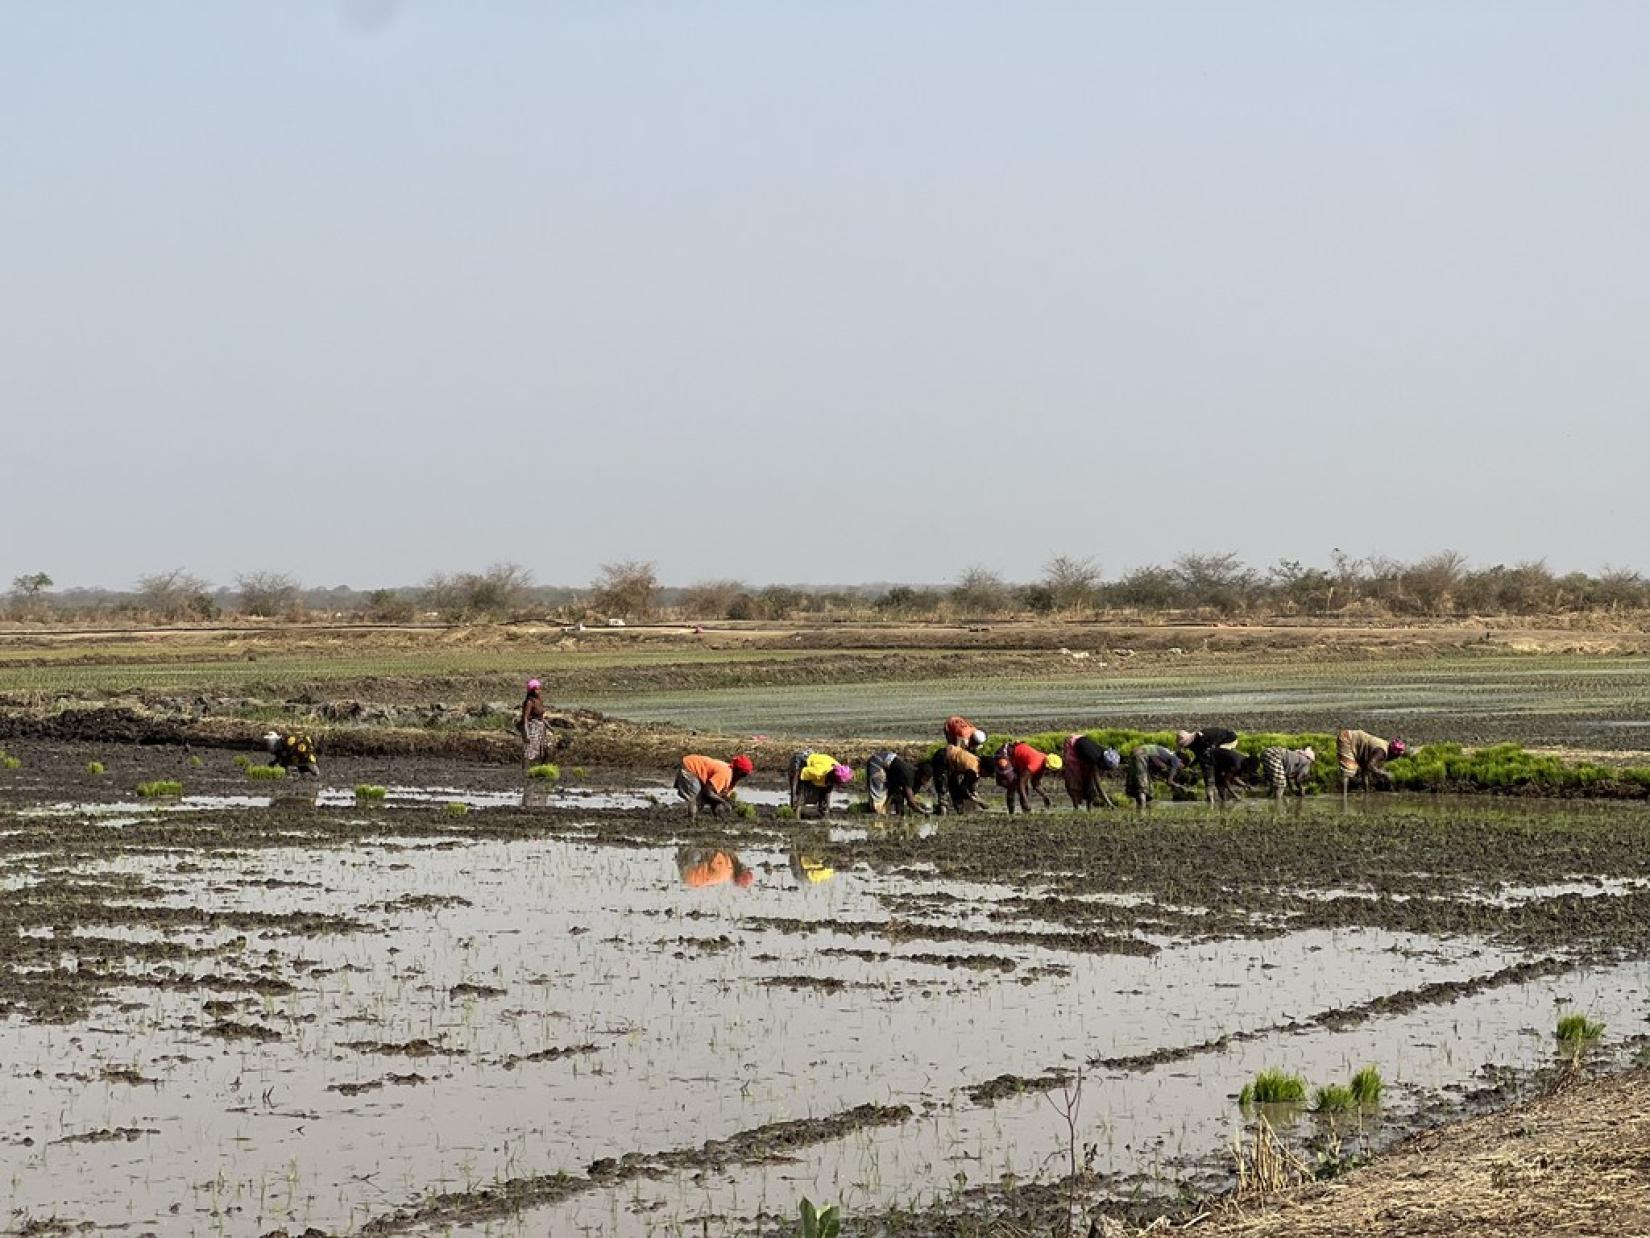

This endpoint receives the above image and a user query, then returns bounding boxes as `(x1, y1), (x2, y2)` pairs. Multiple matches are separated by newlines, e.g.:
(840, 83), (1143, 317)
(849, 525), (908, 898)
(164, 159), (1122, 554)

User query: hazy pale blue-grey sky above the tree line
(0, 0), (1650, 586)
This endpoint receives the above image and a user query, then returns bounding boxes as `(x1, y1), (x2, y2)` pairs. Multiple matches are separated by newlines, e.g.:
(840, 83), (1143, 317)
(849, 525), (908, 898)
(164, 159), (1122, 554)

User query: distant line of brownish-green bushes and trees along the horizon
(5, 550), (1650, 624)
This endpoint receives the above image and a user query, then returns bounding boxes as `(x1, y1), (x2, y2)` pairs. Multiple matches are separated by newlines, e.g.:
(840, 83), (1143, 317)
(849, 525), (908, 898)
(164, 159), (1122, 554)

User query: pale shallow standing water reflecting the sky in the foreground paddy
(0, 787), (1650, 1235)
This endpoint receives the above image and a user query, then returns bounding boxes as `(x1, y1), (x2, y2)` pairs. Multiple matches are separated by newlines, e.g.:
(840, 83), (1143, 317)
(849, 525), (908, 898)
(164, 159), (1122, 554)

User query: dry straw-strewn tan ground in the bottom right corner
(1181, 1070), (1650, 1238)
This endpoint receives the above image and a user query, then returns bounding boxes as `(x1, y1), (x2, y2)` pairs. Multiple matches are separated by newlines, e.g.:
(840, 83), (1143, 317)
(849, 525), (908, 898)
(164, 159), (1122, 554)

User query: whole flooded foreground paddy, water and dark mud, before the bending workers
(0, 748), (1650, 1235)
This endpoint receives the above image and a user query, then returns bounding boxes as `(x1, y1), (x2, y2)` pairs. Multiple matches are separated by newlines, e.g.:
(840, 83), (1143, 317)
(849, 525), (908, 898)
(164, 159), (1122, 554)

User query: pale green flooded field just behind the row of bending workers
(576, 655), (1650, 749)
